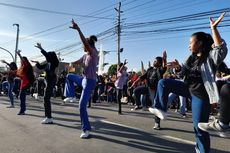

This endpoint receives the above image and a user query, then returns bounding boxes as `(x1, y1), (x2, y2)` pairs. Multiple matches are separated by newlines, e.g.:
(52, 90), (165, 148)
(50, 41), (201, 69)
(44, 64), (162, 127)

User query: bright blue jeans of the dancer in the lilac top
(64, 74), (96, 131)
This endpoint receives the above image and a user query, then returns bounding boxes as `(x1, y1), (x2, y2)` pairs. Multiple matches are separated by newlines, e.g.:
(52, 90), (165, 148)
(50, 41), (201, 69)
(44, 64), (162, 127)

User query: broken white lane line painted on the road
(97, 119), (195, 145)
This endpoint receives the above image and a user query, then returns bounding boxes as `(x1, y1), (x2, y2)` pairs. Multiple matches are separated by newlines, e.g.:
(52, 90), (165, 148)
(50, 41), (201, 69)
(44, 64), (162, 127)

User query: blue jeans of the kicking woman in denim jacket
(154, 79), (210, 153)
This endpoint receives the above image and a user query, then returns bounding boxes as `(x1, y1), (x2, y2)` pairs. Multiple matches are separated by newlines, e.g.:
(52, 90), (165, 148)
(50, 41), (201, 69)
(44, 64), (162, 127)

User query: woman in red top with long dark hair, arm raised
(17, 50), (34, 115)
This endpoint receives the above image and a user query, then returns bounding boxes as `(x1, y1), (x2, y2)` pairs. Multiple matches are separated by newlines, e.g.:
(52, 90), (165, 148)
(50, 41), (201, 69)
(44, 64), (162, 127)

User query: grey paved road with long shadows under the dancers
(0, 96), (230, 153)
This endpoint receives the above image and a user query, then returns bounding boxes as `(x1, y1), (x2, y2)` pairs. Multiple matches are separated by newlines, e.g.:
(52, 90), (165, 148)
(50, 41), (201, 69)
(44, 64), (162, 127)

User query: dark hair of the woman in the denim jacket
(191, 32), (214, 64)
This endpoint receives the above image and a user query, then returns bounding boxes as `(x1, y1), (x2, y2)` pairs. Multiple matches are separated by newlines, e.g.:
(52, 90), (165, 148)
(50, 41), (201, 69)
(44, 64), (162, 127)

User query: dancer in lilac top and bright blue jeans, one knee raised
(64, 20), (99, 138)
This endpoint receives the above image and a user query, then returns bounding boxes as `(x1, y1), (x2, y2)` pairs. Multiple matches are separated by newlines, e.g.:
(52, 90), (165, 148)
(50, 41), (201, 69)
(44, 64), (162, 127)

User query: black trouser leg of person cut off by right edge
(220, 83), (230, 125)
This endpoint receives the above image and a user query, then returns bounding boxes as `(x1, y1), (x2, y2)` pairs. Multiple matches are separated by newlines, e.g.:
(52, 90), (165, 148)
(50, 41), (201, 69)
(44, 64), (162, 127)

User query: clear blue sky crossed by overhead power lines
(0, 0), (230, 70)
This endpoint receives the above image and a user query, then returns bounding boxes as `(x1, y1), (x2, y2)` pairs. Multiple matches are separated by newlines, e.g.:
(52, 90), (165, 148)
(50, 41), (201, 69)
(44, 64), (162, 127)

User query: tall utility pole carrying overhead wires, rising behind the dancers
(115, 2), (122, 114)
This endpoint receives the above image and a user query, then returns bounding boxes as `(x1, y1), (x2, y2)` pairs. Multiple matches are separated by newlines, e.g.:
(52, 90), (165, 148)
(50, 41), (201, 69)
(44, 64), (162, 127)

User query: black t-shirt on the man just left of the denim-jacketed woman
(140, 67), (166, 90)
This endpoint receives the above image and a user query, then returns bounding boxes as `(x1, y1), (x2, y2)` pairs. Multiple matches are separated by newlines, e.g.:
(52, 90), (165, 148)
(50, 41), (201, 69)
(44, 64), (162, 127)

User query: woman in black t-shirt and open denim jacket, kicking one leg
(149, 13), (227, 153)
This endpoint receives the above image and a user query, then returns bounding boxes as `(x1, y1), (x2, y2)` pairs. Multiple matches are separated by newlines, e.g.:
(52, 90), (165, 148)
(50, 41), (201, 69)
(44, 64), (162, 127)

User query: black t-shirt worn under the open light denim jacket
(185, 55), (209, 100)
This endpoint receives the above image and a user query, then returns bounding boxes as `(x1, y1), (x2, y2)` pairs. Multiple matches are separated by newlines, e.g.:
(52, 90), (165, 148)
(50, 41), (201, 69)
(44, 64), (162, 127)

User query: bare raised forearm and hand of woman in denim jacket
(209, 12), (225, 46)
